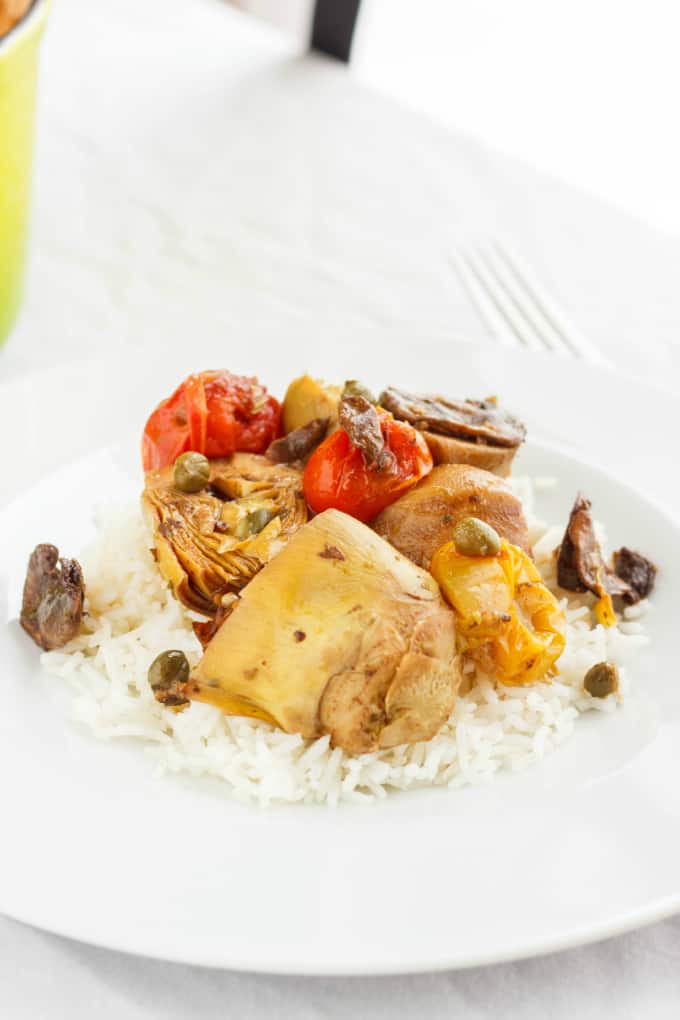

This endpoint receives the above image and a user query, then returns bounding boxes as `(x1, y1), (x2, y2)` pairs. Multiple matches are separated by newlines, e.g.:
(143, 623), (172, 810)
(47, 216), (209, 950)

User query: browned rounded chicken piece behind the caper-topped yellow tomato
(372, 464), (530, 569)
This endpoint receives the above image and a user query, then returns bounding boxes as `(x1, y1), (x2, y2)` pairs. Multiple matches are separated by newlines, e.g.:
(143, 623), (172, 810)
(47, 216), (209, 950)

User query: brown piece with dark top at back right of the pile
(379, 387), (526, 477)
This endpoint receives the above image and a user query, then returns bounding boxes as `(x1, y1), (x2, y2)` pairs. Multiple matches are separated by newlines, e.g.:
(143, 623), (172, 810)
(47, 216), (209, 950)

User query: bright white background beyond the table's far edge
(237, 0), (680, 233)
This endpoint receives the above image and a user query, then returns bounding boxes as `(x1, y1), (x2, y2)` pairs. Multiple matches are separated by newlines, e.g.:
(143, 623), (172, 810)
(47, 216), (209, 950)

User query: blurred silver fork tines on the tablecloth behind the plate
(454, 239), (607, 364)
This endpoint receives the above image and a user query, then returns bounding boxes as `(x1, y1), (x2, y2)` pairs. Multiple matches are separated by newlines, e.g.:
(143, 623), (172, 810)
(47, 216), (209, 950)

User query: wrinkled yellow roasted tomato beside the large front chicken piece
(430, 539), (566, 684)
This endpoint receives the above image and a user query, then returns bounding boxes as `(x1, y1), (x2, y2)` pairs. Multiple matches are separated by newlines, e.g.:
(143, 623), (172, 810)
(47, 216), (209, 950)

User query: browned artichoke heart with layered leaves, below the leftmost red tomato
(142, 453), (307, 616)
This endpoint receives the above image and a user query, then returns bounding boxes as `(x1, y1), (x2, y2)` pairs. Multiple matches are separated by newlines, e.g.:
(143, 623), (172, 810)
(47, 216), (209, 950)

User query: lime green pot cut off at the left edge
(0, 0), (50, 345)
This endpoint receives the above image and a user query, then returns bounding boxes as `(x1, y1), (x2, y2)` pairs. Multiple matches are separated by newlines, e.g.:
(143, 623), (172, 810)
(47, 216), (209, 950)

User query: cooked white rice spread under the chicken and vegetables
(42, 478), (648, 805)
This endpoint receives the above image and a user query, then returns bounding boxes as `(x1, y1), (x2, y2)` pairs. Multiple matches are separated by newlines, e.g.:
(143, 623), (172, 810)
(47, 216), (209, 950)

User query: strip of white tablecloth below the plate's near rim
(0, 918), (680, 1020)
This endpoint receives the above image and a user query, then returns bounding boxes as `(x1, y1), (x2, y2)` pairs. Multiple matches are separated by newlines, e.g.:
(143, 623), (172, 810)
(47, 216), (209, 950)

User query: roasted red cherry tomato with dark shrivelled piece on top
(303, 408), (432, 521)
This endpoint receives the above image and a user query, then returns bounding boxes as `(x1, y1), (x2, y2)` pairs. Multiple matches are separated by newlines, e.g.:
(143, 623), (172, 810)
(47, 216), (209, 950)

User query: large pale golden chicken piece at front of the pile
(186, 510), (461, 754)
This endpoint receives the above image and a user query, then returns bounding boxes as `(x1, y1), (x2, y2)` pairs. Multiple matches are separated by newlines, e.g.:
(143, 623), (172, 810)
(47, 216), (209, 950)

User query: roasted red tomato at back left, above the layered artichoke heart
(142, 371), (281, 471)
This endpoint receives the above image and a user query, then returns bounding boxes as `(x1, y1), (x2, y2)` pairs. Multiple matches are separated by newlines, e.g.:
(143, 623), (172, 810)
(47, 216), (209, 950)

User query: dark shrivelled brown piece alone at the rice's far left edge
(20, 545), (85, 652)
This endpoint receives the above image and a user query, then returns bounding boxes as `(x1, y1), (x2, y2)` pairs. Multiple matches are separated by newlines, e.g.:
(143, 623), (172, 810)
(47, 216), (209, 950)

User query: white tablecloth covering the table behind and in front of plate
(0, 0), (680, 1020)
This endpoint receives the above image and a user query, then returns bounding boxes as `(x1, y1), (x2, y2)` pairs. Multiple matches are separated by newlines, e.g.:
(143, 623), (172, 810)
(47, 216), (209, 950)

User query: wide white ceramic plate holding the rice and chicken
(0, 342), (680, 974)
